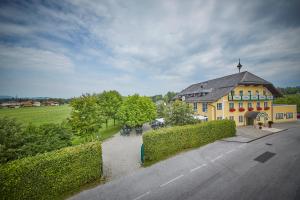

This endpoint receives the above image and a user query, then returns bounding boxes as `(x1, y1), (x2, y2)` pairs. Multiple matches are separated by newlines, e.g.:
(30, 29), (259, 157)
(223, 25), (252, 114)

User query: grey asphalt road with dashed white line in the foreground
(72, 128), (300, 200)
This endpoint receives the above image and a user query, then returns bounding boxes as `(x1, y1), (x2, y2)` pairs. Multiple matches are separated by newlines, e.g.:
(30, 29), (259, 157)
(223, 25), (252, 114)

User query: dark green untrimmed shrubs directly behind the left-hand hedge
(0, 118), (72, 163)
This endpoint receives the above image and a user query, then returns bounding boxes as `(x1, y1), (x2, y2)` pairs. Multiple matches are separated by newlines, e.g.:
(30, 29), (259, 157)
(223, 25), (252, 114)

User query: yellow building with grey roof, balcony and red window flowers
(175, 71), (297, 126)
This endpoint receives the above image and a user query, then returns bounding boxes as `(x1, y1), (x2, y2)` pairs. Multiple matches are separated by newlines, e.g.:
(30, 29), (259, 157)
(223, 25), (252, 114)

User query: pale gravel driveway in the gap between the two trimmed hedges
(102, 125), (149, 180)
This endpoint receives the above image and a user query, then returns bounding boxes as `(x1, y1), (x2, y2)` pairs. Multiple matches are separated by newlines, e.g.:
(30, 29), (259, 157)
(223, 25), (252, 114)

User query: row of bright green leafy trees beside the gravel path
(69, 91), (156, 135)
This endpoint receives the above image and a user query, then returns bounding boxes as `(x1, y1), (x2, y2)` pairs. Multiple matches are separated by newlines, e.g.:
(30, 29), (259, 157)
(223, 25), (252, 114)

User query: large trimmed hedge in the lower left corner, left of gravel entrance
(0, 142), (102, 199)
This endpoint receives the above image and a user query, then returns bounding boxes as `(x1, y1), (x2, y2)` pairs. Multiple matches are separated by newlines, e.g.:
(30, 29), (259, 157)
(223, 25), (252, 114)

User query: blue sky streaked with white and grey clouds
(0, 0), (300, 98)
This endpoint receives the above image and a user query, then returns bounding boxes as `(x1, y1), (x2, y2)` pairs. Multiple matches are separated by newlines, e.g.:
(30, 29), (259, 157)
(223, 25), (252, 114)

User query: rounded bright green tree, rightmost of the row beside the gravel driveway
(117, 94), (156, 127)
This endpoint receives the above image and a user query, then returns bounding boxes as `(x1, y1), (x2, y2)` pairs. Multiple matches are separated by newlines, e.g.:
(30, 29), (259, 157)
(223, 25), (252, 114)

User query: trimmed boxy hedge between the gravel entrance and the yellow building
(143, 120), (236, 164)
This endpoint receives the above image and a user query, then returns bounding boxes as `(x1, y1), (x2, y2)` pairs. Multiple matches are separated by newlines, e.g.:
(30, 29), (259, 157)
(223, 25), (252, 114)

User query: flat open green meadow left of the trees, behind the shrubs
(0, 105), (71, 125)
